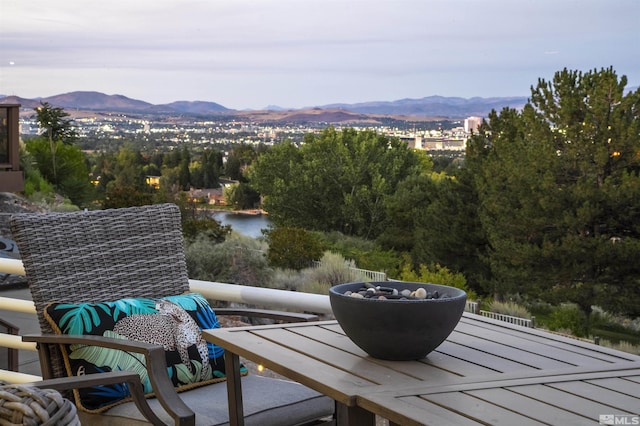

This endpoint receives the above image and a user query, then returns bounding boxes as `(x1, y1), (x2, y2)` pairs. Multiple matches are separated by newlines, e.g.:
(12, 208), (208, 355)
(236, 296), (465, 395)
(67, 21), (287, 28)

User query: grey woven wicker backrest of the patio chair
(10, 204), (189, 377)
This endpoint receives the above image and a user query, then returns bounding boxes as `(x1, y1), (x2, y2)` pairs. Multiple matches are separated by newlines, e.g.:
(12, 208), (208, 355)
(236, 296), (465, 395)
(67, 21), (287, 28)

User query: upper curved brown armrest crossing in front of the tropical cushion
(22, 334), (195, 426)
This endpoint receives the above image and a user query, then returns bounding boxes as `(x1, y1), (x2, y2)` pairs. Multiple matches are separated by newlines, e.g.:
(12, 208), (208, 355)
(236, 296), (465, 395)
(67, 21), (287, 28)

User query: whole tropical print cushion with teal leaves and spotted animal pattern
(45, 293), (247, 412)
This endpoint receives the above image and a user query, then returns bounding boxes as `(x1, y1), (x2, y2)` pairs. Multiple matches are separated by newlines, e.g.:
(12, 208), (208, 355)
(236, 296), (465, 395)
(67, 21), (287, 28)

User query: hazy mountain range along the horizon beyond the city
(0, 91), (527, 121)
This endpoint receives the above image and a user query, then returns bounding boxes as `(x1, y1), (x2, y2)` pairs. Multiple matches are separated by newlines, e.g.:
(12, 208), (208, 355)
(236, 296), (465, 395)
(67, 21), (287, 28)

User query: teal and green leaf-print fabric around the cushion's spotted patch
(45, 293), (247, 412)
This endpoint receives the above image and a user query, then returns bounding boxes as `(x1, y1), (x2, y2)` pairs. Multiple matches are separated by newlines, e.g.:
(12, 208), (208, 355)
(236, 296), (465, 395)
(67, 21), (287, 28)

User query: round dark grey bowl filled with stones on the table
(329, 281), (467, 361)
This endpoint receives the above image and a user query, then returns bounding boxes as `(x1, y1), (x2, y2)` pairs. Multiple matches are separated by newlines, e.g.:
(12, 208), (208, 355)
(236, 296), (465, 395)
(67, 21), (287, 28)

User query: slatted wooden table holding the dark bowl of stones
(204, 313), (640, 425)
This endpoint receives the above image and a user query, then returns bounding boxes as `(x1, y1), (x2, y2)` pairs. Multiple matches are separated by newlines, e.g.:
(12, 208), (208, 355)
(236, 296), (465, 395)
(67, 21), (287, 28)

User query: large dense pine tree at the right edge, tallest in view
(468, 68), (640, 315)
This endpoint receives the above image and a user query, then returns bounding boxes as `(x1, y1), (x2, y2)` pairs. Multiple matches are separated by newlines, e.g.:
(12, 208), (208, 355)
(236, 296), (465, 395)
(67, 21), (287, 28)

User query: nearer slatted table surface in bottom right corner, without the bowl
(357, 368), (640, 426)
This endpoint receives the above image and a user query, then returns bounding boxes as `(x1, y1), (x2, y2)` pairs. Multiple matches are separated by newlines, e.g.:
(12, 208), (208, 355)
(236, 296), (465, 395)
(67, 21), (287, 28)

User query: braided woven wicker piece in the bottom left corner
(0, 384), (80, 426)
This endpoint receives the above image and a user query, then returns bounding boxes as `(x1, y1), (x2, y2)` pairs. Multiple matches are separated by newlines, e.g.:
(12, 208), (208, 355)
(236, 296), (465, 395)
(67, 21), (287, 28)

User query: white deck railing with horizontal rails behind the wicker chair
(0, 258), (332, 383)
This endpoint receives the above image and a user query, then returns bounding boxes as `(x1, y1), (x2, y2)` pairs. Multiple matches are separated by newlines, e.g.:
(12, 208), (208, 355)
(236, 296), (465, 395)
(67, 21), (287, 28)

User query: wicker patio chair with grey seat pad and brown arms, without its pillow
(10, 204), (334, 425)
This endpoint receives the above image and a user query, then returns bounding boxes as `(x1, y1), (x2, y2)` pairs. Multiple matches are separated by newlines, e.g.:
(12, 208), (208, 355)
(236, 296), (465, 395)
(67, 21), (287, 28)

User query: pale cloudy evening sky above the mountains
(0, 0), (640, 109)
